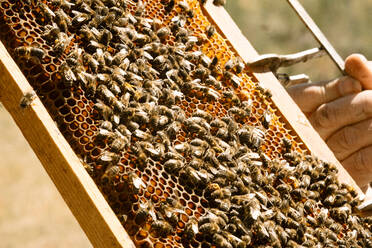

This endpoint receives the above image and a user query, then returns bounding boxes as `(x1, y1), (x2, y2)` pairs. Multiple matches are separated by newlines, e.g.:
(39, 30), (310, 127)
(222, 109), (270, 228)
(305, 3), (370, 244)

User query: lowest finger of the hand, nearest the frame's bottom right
(341, 146), (372, 187)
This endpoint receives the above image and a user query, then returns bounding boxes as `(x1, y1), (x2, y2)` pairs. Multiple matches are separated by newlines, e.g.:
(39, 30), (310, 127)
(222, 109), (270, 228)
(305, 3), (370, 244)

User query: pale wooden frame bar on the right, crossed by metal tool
(204, 0), (364, 196)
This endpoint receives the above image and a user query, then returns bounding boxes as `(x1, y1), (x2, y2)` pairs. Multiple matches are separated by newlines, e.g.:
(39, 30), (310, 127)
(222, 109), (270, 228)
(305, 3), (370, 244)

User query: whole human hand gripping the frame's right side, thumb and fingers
(288, 54), (372, 187)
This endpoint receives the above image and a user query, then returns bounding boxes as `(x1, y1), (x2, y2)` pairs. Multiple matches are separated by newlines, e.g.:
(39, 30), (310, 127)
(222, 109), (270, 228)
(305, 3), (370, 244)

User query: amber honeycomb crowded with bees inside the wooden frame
(0, 0), (372, 248)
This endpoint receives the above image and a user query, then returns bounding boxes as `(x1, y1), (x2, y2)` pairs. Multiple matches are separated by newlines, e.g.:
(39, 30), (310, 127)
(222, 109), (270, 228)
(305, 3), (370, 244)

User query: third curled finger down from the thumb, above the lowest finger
(327, 119), (372, 161)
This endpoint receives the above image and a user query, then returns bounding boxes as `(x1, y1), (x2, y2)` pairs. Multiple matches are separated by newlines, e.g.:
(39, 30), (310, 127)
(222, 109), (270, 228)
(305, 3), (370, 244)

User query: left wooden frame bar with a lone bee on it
(0, 42), (135, 248)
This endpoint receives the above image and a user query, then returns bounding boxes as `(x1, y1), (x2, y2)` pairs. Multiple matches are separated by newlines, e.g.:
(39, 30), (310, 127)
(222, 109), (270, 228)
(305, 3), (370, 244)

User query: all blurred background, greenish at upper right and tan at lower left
(0, 0), (372, 248)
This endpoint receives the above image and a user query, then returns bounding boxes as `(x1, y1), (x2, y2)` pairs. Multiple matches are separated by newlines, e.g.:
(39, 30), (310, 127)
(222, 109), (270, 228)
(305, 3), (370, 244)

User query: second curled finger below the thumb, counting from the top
(309, 90), (372, 140)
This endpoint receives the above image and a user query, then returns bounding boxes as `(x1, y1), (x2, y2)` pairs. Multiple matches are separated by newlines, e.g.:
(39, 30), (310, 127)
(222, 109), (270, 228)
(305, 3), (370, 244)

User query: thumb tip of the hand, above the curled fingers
(345, 54), (372, 90)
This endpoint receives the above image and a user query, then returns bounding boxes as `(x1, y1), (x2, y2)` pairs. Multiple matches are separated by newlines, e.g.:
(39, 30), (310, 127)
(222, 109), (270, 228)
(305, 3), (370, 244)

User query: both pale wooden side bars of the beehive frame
(0, 1), (363, 248)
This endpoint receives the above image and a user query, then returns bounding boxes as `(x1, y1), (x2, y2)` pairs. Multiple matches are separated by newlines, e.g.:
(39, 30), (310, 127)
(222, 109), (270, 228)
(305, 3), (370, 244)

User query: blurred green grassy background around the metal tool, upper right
(226, 0), (372, 81)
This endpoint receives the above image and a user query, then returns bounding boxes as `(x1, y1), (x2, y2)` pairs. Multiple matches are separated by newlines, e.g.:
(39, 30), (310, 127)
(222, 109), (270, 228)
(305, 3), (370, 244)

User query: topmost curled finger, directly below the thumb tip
(287, 77), (362, 113)
